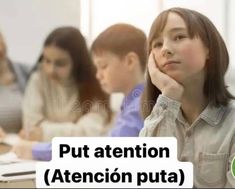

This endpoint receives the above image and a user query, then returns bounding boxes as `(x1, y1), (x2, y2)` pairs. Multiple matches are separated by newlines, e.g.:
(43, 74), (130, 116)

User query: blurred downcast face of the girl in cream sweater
(42, 46), (73, 81)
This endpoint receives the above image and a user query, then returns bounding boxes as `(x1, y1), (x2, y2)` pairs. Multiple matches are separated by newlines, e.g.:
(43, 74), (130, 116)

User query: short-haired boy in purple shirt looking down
(91, 23), (146, 136)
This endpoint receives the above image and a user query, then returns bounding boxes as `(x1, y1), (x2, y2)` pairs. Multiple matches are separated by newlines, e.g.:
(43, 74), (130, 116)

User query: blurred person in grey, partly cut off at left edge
(0, 30), (29, 134)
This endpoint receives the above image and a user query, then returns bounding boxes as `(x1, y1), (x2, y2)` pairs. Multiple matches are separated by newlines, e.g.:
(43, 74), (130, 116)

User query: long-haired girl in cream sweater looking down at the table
(21, 27), (111, 141)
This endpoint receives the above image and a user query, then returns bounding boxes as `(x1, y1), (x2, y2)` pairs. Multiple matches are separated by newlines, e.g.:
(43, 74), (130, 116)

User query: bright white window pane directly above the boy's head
(91, 0), (160, 40)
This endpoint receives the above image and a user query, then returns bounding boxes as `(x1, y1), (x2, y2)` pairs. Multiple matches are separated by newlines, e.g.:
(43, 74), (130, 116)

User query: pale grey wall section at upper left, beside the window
(0, 0), (80, 64)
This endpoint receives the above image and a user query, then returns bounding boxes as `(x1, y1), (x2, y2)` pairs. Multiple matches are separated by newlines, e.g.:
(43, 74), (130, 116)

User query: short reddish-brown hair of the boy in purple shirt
(91, 24), (146, 71)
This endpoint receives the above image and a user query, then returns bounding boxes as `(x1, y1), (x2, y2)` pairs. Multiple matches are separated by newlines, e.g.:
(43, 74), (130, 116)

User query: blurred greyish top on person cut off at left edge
(0, 83), (22, 133)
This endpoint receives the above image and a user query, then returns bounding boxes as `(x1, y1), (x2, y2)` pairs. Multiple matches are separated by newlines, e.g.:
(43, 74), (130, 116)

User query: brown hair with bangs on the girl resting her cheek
(141, 8), (234, 118)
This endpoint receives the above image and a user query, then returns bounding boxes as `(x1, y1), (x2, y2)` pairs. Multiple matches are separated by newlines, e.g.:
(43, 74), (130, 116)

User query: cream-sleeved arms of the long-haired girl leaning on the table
(21, 73), (110, 141)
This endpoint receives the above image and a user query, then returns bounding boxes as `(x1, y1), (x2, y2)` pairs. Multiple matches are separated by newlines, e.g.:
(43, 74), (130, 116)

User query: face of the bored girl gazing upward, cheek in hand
(151, 13), (208, 84)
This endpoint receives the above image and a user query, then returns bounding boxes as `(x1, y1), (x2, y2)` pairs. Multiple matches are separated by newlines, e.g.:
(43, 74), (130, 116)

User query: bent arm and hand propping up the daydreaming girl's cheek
(140, 52), (184, 136)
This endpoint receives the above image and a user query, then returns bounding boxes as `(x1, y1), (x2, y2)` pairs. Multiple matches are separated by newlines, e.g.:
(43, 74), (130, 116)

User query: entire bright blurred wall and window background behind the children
(0, 0), (235, 103)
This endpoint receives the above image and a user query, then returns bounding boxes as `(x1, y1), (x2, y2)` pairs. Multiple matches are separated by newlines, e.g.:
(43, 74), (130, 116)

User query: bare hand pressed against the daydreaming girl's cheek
(148, 52), (184, 101)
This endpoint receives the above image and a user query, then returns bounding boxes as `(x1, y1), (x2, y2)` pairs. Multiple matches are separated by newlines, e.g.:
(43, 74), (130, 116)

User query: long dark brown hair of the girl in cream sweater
(35, 27), (111, 121)
